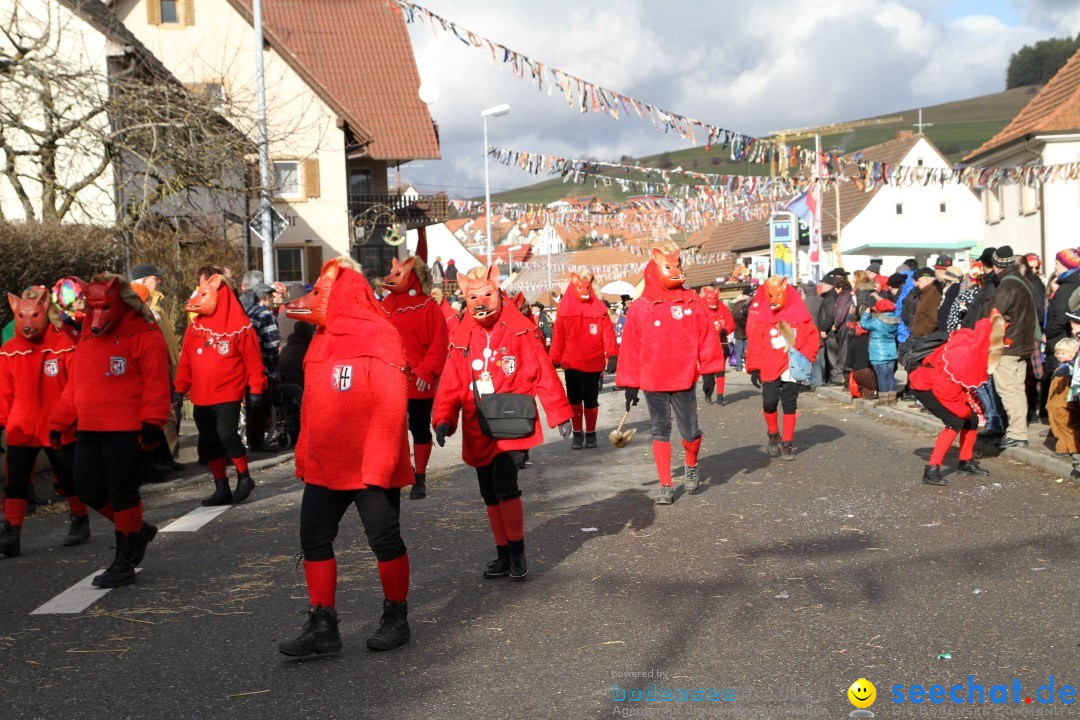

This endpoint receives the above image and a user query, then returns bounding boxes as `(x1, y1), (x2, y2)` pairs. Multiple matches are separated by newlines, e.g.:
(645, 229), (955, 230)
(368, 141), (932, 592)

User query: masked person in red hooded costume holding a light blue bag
(746, 275), (821, 460)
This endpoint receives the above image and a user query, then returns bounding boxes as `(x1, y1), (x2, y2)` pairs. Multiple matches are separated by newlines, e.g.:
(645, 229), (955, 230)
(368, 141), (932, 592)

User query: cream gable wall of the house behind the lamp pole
(113, 0), (352, 279)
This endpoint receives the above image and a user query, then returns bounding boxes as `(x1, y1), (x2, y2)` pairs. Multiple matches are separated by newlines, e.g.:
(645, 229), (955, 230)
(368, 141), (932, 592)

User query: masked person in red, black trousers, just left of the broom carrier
(551, 273), (619, 450)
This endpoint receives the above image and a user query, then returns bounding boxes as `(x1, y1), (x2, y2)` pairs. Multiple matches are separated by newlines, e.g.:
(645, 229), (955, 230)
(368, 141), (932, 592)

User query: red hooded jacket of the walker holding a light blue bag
(746, 285), (821, 382)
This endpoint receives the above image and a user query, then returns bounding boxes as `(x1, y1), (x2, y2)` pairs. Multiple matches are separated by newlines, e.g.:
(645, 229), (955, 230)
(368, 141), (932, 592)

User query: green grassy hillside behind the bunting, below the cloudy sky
(488, 85), (1039, 208)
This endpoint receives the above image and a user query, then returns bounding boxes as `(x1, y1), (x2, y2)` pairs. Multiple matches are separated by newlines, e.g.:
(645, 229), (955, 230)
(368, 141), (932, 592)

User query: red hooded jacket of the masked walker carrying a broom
(616, 262), (724, 392)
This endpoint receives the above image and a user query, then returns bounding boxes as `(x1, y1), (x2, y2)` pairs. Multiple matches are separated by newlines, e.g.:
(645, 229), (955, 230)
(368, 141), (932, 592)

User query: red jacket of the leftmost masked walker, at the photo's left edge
(0, 324), (75, 447)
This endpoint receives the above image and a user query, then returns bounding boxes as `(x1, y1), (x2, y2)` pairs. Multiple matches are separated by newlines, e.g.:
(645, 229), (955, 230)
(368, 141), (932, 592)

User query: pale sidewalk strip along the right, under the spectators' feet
(814, 386), (1072, 478)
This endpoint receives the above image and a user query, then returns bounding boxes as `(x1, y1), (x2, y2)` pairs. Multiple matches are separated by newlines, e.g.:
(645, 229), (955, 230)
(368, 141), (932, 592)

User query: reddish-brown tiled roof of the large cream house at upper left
(229, 0), (440, 160)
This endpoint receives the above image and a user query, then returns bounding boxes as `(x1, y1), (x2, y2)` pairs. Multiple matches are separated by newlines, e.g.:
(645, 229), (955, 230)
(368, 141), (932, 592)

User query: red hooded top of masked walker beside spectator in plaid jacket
(175, 285), (267, 405)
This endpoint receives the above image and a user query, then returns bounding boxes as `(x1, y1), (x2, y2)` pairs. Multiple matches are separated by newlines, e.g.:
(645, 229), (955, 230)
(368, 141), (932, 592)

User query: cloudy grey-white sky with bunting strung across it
(402, 0), (1080, 198)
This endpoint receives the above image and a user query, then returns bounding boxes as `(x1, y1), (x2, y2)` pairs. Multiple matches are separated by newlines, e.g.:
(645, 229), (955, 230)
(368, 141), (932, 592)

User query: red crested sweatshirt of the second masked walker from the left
(50, 310), (170, 433)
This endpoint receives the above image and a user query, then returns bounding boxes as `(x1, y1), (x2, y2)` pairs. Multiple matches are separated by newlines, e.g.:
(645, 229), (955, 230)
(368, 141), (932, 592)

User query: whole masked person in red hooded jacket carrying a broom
(617, 248), (724, 505)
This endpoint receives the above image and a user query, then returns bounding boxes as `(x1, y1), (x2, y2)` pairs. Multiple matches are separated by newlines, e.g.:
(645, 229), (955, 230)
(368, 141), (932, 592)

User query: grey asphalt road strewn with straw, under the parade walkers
(0, 377), (1080, 720)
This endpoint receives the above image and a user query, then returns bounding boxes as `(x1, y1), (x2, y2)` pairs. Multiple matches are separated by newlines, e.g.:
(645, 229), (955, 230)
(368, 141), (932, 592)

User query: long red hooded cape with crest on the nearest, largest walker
(296, 269), (412, 490)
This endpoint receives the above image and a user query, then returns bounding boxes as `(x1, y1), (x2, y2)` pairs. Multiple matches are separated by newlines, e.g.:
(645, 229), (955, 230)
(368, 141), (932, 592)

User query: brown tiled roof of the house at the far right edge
(963, 50), (1080, 162)
